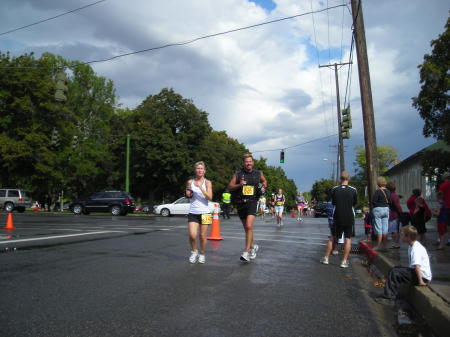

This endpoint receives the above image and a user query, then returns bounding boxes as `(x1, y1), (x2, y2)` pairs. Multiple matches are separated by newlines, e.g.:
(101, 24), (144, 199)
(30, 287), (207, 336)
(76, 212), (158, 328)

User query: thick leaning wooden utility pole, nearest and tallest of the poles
(352, 0), (378, 201)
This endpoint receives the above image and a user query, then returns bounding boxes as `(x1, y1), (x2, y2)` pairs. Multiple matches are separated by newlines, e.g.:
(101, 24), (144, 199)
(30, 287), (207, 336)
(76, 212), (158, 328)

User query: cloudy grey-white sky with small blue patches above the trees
(0, 0), (450, 190)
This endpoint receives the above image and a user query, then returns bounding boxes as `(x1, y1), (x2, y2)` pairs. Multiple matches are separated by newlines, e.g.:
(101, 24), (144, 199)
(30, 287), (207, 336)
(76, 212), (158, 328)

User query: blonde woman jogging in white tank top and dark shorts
(185, 161), (212, 263)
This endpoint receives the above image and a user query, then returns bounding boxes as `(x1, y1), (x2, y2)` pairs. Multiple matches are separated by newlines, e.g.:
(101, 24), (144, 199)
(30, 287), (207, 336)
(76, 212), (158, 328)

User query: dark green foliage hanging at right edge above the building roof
(412, 18), (450, 144)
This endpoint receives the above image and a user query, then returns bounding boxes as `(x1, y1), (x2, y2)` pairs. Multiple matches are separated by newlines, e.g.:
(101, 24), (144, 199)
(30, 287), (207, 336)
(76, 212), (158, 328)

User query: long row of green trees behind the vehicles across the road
(0, 53), (296, 205)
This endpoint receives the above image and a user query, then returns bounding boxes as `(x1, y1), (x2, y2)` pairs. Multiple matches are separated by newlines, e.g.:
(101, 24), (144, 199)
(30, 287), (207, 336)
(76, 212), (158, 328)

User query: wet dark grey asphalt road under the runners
(0, 214), (395, 337)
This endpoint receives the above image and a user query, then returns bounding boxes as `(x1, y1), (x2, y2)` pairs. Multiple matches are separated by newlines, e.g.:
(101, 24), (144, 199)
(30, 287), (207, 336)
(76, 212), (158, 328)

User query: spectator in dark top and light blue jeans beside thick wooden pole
(372, 177), (391, 250)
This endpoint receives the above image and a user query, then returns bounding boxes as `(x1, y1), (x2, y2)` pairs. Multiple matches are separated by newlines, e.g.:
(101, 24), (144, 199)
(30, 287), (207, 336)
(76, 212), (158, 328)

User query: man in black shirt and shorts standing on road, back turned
(320, 171), (358, 268)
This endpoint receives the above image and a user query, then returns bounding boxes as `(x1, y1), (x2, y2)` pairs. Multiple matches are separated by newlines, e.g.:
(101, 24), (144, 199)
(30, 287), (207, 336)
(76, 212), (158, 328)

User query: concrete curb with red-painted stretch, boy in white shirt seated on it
(359, 241), (450, 337)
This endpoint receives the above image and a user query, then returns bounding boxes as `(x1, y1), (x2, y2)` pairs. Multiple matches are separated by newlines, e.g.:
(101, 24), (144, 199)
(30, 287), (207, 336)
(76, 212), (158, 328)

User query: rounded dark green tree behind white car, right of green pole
(117, 89), (212, 202)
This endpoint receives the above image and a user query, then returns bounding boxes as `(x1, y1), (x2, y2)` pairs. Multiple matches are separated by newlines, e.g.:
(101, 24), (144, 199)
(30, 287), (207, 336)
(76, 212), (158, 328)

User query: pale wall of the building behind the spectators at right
(389, 158), (436, 210)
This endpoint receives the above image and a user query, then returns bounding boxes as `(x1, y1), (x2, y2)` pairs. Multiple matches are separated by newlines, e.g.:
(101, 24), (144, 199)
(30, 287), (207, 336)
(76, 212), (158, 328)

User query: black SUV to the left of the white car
(69, 191), (135, 216)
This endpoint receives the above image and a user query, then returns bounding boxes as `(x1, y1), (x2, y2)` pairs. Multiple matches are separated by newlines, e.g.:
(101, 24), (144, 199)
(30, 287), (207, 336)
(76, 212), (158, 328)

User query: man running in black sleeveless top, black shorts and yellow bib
(228, 154), (267, 262)
